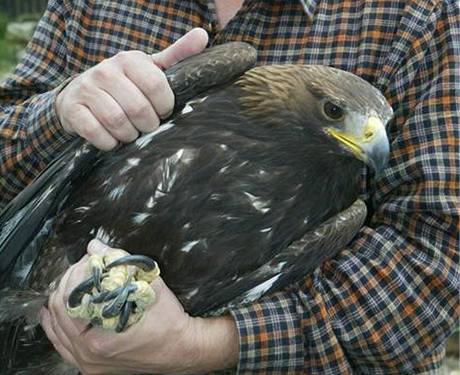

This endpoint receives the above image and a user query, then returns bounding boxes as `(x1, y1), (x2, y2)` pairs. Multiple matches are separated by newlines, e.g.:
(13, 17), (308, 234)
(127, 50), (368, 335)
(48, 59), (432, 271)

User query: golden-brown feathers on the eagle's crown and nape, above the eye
(236, 65), (393, 123)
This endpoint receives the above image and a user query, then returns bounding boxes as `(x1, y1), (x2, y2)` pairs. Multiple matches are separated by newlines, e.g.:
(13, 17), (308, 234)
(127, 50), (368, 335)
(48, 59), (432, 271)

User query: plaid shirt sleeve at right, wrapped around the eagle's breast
(232, 1), (460, 375)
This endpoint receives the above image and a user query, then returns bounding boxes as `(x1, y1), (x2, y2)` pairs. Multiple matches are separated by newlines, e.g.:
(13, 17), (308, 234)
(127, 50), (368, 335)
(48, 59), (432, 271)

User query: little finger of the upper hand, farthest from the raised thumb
(72, 104), (118, 151)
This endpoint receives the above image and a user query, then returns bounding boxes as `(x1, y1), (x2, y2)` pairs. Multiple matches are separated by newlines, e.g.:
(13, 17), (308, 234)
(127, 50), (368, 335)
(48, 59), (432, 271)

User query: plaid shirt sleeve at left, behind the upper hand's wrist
(0, 0), (71, 209)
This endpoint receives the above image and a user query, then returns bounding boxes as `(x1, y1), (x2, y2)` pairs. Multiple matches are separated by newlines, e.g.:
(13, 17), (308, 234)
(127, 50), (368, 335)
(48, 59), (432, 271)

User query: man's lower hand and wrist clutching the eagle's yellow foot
(41, 240), (238, 374)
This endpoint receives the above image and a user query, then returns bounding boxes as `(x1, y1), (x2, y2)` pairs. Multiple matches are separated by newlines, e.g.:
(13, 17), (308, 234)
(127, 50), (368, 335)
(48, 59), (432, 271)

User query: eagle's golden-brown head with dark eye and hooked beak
(237, 65), (393, 175)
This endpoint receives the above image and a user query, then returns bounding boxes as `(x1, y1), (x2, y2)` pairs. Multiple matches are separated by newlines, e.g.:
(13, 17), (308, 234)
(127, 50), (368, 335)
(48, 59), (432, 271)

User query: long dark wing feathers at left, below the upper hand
(0, 139), (99, 287)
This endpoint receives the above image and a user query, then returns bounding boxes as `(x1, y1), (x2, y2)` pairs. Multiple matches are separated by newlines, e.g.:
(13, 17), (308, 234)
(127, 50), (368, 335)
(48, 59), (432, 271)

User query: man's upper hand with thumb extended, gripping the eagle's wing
(56, 28), (208, 150)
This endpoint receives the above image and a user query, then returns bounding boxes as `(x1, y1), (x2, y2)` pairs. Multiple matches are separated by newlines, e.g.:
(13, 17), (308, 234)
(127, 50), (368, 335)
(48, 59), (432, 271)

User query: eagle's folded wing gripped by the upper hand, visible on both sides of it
(0, 42), (257, 287)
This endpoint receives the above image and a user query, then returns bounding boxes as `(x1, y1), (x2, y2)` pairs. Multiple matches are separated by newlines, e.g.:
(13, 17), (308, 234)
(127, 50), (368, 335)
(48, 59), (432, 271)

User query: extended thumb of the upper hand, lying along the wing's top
(152, 27), (208, 69)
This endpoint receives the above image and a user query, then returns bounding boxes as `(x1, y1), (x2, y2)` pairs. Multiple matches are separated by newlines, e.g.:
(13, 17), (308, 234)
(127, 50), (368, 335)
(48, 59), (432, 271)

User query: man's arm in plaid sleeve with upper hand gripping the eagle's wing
(0, 0), (207, 209)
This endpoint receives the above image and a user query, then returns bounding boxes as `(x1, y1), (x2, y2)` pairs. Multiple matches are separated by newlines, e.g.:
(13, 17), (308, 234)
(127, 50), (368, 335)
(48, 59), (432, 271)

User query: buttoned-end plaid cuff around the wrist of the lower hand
(230, 292), (304, 374)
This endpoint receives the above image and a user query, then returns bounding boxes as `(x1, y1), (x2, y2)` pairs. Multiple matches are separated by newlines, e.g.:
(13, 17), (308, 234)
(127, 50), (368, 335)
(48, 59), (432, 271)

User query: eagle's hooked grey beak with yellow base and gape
(326, 116), (390, 176)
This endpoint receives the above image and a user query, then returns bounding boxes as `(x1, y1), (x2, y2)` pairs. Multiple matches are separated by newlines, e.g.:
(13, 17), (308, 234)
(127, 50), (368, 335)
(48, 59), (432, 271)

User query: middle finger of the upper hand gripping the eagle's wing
(101, 72), (160, 132)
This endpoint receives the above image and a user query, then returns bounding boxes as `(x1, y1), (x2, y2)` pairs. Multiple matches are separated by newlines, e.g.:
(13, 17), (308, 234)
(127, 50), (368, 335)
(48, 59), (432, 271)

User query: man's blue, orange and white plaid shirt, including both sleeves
(0, 0), (460, 374)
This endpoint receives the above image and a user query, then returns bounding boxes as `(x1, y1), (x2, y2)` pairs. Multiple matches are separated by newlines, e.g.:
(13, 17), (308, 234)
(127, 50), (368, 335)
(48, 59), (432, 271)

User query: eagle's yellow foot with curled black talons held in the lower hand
(67, 250), (160, 332)
